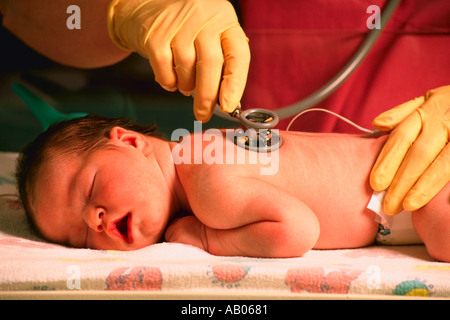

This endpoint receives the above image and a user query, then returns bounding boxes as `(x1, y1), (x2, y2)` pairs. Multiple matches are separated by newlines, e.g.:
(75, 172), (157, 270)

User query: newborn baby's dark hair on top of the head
(15, 115), (162, 223)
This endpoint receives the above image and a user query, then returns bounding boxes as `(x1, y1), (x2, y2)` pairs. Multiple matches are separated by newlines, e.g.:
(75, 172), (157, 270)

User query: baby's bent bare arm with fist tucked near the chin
(166, 172), (320, 257)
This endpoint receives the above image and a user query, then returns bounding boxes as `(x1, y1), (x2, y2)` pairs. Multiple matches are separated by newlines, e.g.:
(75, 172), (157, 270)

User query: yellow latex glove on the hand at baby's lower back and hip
(370, 86), (450, 215)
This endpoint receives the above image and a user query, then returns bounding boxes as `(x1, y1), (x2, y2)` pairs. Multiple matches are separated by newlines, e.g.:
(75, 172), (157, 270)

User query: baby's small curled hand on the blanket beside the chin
(165, 216), (207, 250)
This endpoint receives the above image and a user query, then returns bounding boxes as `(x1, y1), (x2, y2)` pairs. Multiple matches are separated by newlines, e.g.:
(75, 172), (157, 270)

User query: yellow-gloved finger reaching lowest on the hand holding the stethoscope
(194, 32), (224, 122)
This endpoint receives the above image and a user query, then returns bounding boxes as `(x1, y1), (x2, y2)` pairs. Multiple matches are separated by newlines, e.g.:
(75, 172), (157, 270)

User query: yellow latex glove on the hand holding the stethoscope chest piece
(108, 0), (250, 122)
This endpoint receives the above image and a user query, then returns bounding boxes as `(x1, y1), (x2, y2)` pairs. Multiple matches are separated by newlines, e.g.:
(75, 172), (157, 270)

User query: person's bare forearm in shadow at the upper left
(0, 0), (130, 68)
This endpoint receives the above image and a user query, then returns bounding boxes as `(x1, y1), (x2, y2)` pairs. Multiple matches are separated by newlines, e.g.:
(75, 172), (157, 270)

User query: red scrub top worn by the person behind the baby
(240, 0), (450, 133)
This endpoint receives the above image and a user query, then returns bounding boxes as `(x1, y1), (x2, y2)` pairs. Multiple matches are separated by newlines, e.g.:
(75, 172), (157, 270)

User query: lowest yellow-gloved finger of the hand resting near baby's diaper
(403, 144), (450, 211)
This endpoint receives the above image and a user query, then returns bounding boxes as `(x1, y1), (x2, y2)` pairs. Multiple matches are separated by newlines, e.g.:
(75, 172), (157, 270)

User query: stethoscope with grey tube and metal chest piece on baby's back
(219, 0), (401, 152)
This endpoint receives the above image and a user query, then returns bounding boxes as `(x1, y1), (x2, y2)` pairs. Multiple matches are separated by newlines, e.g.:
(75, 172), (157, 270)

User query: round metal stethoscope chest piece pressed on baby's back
(231, 109), (282, 152)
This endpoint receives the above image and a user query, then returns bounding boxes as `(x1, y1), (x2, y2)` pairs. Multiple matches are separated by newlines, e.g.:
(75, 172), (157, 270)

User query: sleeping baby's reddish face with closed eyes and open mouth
(31, 136), (171, 250)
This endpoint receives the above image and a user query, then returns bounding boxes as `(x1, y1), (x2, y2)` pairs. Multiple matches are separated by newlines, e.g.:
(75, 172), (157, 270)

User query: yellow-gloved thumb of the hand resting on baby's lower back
(372, 96), (425, 132)
